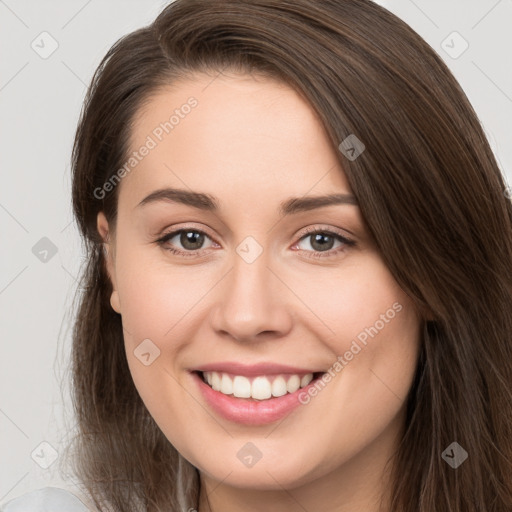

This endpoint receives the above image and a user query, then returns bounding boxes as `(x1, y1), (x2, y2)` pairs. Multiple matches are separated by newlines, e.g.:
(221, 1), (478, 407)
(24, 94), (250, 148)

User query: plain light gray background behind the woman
(0, 0), (512, 503)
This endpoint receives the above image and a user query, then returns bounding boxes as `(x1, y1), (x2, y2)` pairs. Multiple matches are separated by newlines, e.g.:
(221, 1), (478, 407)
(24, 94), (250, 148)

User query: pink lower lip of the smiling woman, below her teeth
(191, 372), (321, 425)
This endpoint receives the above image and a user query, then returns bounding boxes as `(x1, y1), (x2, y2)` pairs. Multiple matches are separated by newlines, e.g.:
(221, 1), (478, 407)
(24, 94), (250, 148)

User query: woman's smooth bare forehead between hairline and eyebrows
(120, 74), (350, 214)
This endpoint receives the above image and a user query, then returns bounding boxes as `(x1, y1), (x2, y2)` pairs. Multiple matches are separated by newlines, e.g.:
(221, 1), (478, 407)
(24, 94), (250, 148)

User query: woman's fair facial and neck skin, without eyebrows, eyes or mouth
(98, 75), (420, 512)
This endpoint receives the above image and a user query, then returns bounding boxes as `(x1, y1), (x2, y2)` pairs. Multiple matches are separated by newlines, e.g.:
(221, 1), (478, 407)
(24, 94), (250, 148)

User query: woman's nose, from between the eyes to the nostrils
(211, 252), (292, 342)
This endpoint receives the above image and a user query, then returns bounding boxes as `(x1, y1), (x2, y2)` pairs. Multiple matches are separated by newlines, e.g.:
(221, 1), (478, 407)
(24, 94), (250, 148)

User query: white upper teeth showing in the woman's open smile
(194, 371), (324, 401)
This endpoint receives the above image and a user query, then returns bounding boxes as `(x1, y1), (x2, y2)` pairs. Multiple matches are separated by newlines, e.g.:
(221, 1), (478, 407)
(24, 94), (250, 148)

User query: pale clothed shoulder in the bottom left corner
(0, 487), (90, 512)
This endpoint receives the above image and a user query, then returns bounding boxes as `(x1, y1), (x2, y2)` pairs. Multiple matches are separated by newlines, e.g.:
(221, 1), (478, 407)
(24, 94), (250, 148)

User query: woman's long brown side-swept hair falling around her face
(66, 0), (512, 512)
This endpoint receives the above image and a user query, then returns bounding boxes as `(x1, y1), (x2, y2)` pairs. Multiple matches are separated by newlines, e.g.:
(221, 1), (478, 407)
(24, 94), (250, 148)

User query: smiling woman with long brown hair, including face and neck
(7, 0), (512, 512)
